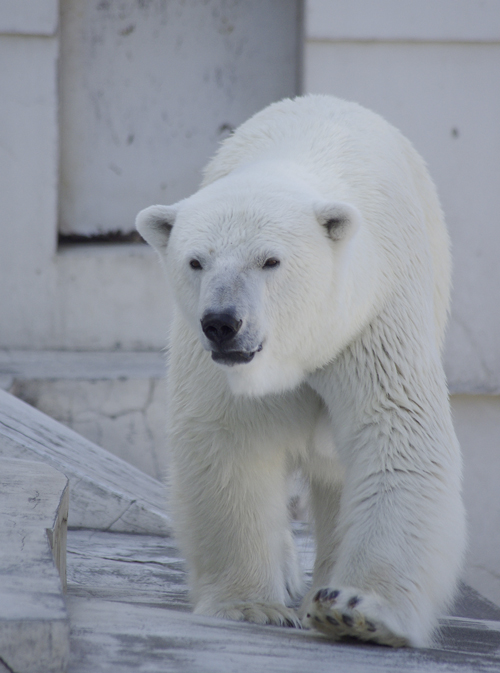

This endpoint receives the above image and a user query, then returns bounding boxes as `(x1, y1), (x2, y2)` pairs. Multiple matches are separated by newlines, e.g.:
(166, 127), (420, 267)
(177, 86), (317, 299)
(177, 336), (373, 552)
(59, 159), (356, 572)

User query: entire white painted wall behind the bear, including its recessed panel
(0, 0), (500, 392)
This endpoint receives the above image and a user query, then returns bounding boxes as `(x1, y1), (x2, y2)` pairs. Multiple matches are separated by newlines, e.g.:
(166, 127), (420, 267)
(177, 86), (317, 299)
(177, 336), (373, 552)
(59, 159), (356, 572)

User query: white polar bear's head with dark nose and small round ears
(136, 163), (377, 395)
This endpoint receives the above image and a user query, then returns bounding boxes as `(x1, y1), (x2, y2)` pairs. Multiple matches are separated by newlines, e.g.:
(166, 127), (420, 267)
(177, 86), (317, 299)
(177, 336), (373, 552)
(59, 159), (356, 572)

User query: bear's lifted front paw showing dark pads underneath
(303, 587), (409, 647)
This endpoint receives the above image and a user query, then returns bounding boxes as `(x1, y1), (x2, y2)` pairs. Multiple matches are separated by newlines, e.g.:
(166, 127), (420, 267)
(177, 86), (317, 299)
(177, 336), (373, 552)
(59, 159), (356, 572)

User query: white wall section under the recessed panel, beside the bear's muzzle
(56, 244), (172, 351)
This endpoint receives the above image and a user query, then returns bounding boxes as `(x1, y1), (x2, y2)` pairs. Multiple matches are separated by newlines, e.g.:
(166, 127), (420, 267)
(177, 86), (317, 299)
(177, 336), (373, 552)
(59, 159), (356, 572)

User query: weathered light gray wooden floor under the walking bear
(67, 525), (500, 673)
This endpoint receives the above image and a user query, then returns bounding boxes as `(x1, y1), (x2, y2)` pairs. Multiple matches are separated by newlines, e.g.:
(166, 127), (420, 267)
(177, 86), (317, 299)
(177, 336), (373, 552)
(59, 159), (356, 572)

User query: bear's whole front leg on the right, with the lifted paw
(302, 334), (465, 646)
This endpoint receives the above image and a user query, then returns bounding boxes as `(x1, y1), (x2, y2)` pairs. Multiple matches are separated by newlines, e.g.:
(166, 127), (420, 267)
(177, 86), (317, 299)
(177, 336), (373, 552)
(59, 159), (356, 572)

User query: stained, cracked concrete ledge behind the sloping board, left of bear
(0, 350), (167, 480)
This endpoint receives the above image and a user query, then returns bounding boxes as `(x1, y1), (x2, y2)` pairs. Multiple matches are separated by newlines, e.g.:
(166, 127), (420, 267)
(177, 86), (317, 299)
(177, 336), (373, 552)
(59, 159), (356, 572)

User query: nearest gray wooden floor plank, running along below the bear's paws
(69, 598), (500, 673)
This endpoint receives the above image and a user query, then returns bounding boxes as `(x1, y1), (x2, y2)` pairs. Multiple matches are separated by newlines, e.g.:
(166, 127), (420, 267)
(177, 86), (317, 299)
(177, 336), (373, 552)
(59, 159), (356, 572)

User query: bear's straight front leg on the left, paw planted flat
(171, 412), (301, 627)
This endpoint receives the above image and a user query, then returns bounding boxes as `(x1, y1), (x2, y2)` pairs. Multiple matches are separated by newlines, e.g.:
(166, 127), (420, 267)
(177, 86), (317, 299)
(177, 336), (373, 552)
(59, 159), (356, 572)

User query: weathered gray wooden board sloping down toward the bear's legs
(0, 390), (170, 535)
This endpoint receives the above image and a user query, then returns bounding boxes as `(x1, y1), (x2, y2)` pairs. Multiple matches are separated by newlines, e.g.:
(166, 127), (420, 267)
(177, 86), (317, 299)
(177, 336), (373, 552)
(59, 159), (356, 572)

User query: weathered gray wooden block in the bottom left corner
(0, 458), (69, 673)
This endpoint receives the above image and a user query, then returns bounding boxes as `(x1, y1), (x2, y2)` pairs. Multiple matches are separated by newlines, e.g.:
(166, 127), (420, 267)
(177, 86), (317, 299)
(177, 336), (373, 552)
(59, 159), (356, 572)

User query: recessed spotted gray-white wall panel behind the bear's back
(59, 0), (299, 234)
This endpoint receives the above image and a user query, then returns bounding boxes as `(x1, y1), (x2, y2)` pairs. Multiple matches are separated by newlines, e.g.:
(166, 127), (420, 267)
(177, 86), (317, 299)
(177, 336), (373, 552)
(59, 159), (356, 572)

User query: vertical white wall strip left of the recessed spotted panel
(0, 31), (58, 347)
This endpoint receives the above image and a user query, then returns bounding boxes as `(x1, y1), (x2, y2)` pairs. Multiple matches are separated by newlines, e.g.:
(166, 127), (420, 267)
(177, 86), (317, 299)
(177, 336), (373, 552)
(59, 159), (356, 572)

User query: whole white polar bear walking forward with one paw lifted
(137, 96), (465, 646)
